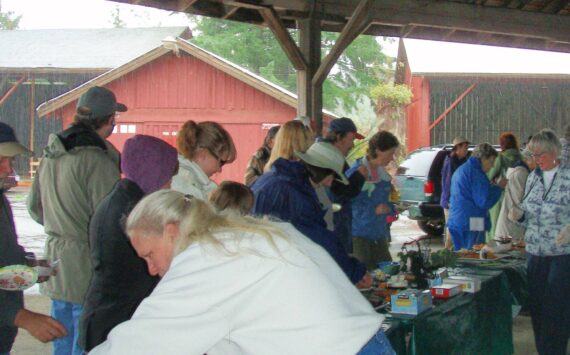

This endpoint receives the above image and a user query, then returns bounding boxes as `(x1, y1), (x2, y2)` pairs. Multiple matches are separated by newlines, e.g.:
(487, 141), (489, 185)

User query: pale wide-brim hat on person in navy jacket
(295, 142), (348, 185)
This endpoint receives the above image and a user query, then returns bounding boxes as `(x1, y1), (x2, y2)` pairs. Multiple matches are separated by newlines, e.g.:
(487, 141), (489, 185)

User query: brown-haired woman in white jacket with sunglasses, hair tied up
(172, 121), (236, 201)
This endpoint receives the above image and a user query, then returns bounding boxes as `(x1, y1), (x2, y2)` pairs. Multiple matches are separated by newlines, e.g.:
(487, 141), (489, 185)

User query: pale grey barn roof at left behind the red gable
(0, 27), (192, 71)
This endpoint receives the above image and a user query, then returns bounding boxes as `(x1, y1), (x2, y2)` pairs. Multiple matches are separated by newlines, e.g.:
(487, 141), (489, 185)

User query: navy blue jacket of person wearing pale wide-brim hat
(251, 159), (366, 283)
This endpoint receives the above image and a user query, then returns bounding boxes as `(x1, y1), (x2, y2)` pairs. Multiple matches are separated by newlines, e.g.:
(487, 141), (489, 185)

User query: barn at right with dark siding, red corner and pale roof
(397, 39), (570, 151)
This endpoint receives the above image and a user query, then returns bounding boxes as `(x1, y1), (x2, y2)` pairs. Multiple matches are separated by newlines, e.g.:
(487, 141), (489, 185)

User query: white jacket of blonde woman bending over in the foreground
(90, 223), (383, 355)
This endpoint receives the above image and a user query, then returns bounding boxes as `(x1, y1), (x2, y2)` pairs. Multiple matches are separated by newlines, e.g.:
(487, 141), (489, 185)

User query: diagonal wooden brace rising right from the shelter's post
(313, 0), (372, 85)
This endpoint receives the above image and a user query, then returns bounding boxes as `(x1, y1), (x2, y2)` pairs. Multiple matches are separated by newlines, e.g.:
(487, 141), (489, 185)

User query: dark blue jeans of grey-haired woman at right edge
(527, 254), (570, 355)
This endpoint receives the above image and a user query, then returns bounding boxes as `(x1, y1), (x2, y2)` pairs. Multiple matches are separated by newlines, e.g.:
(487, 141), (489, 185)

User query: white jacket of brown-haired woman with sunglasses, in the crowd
(171, 155), (217, 201)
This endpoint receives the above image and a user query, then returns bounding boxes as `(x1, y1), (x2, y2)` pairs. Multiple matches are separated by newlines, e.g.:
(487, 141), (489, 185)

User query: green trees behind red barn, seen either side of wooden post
(189, 16), (393, 111)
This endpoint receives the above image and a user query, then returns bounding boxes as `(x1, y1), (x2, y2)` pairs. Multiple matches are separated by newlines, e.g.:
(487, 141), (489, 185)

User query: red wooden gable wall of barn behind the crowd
(61, 54), (297, 182)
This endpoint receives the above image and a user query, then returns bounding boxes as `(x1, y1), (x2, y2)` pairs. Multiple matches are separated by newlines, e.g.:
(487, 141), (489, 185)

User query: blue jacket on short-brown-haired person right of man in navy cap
(347, 158), (395, 240)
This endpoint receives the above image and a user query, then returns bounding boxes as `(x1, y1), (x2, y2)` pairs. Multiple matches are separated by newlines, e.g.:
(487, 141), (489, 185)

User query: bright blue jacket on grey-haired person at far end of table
(447, 157), (502, 231)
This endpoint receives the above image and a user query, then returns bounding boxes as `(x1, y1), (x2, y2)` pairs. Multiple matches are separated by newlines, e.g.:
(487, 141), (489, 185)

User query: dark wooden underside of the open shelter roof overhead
(112, 0), (570, 52)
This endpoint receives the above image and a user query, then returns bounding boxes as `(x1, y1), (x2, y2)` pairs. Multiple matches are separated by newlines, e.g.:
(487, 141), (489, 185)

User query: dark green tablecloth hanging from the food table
(388, 267), (514, 355)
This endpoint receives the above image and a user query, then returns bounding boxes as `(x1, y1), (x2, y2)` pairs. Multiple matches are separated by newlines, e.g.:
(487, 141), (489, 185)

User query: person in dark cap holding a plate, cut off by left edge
(0, 122), (66, 354)
